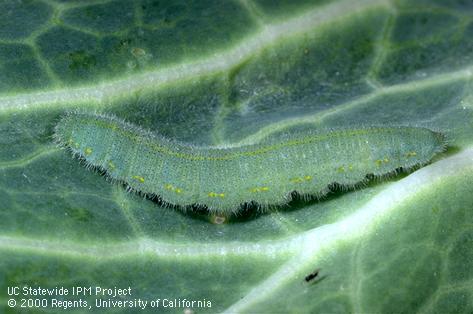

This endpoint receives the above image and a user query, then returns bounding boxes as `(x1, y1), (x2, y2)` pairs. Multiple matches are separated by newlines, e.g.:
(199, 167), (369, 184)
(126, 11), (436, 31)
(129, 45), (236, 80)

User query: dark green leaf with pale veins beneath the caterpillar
(0, 0), (473, 313)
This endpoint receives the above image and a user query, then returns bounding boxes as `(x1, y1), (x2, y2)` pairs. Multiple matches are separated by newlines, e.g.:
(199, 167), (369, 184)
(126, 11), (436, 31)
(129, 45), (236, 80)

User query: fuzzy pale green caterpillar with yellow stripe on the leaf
(55, 112), (445, 215)
